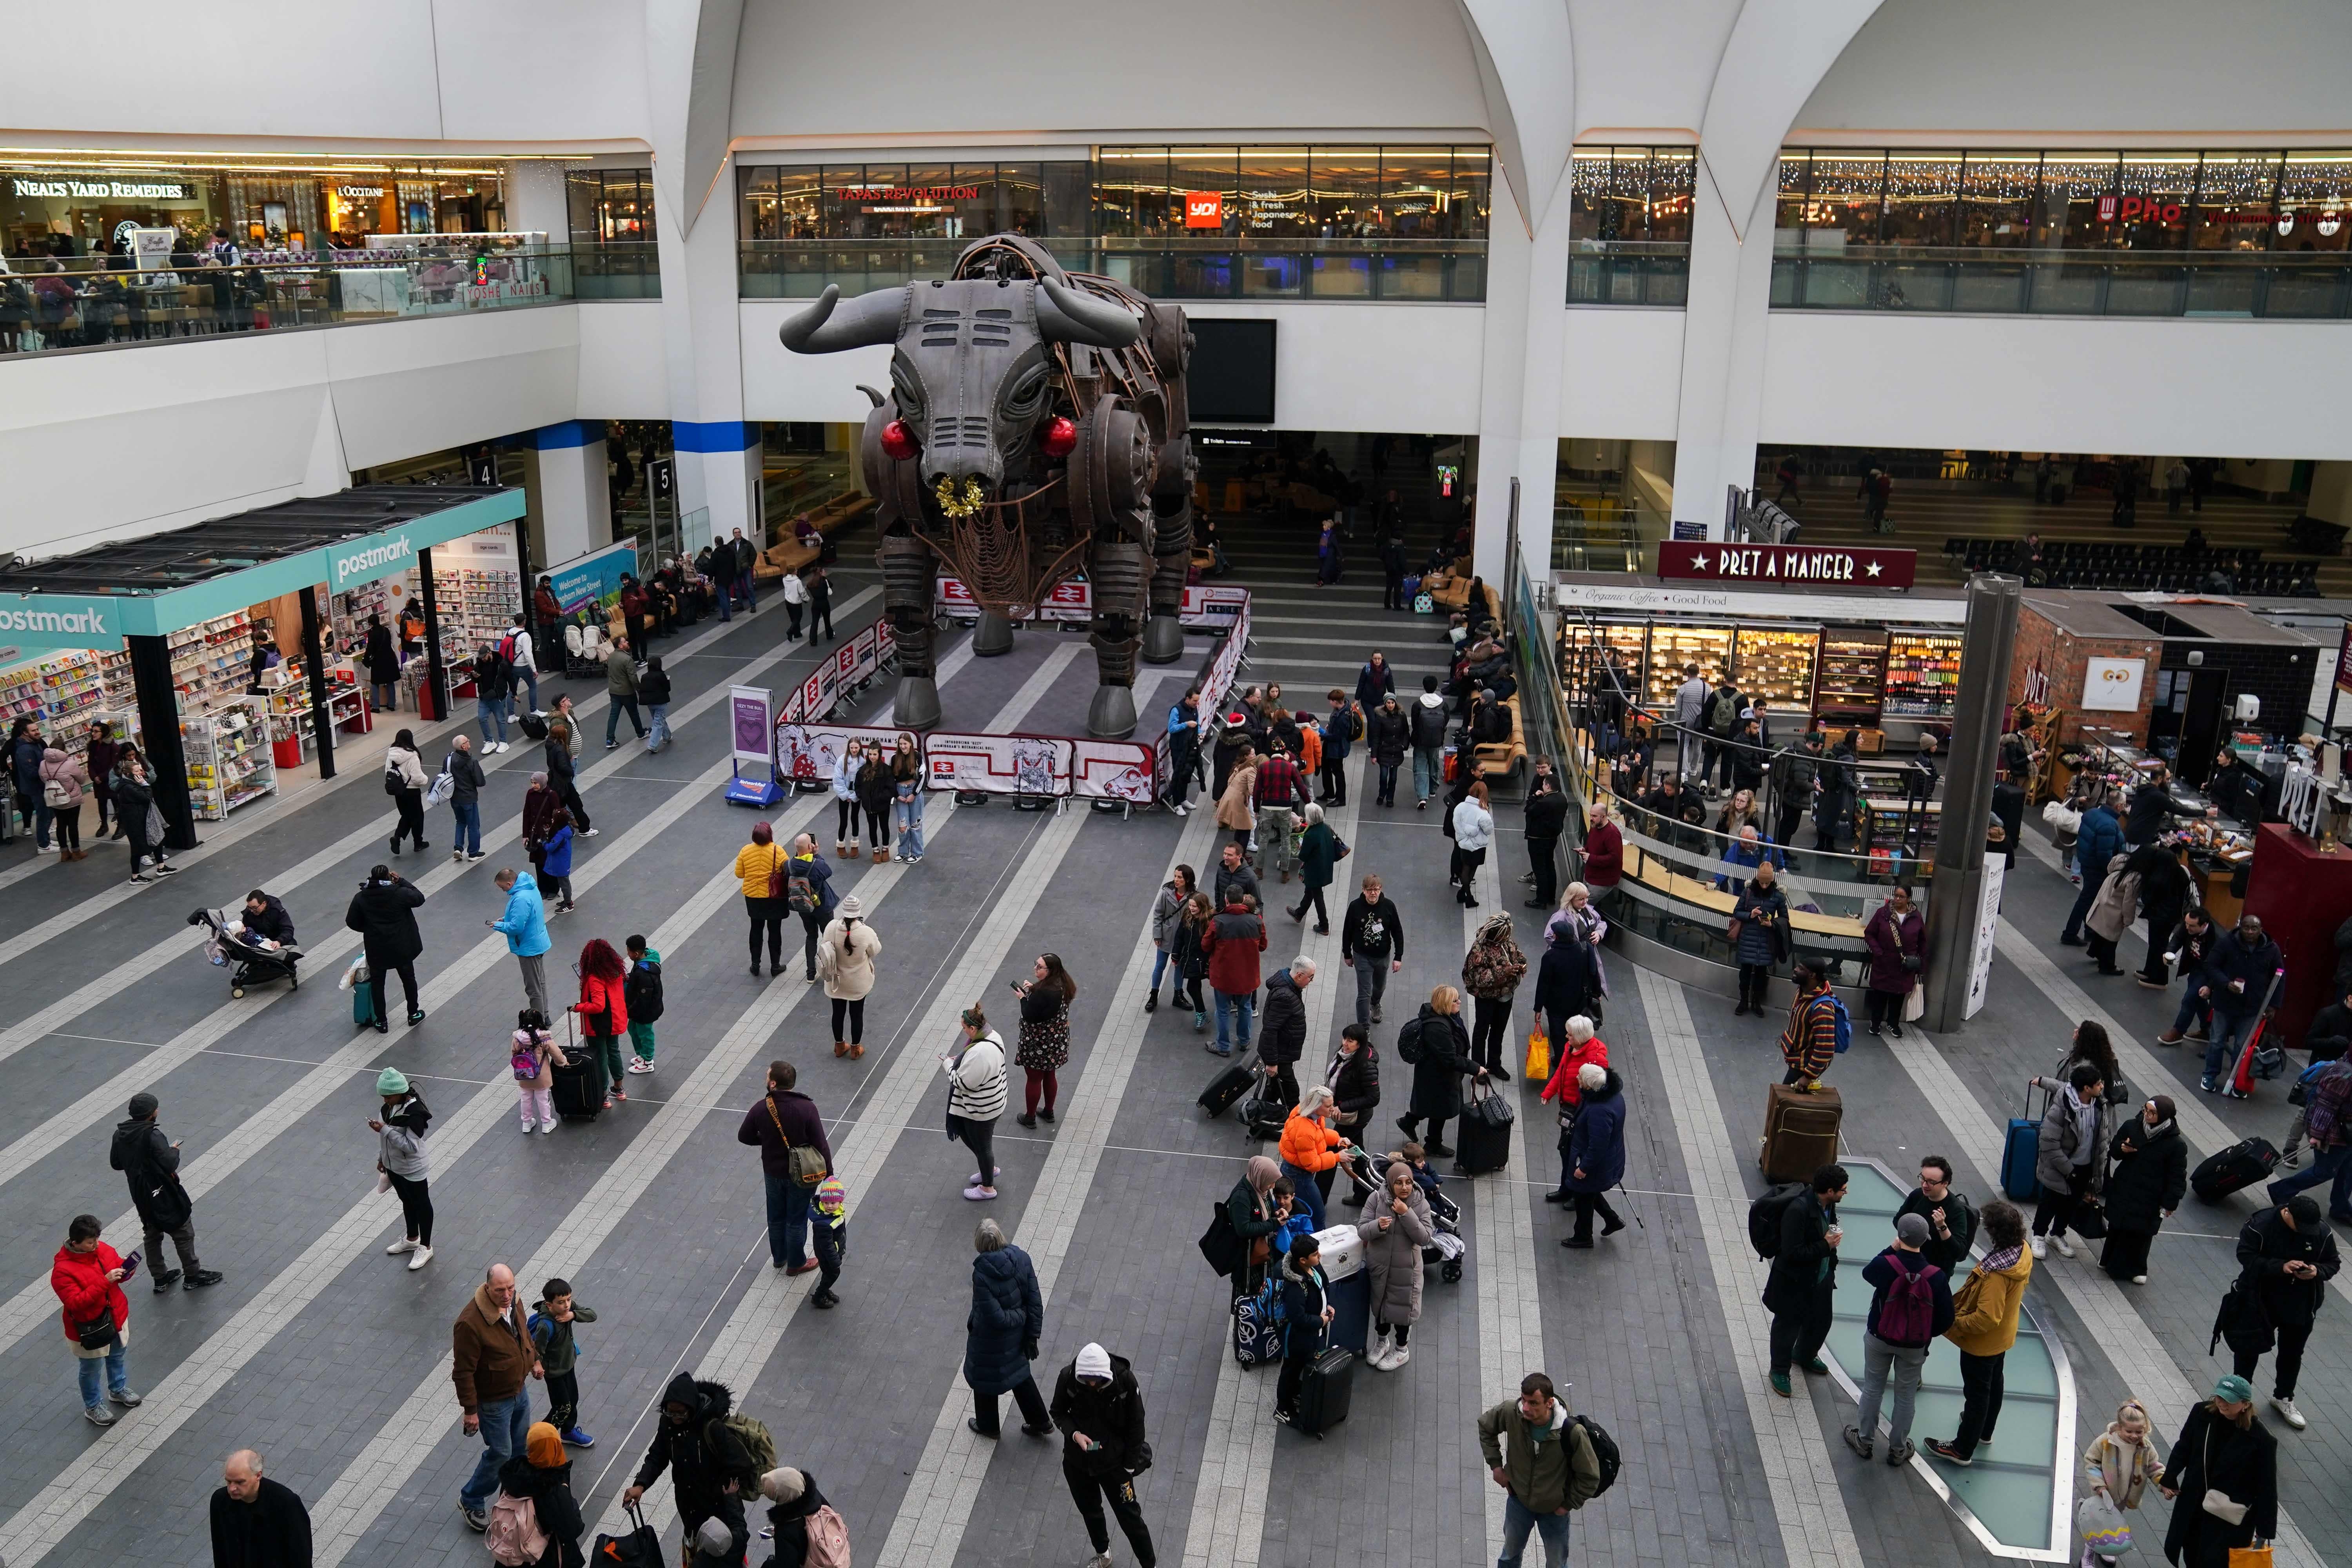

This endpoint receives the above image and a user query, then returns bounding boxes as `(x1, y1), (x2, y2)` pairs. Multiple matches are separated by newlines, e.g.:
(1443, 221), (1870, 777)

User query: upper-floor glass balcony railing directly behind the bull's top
(741, 235), (1486, 301)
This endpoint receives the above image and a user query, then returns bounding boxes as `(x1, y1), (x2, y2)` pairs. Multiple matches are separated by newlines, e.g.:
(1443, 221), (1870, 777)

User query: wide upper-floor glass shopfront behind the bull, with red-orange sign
(739, 146), (1486, 299)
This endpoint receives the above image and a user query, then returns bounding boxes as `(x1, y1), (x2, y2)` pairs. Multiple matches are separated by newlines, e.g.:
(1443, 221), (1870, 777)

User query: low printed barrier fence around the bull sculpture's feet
(739, 578), (1249, 806)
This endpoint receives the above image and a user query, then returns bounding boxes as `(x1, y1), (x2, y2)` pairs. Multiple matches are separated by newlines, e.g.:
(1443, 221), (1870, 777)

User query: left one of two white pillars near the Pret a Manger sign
(1470, 179), (1569, 585)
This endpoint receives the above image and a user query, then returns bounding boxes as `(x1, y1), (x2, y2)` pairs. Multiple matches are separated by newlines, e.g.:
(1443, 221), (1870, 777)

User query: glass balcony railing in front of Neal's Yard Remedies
(0, 245), (616, 355)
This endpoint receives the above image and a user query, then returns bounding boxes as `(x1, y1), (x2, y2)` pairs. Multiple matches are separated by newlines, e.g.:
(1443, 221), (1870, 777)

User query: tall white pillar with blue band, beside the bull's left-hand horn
(654, 154), (762, 545)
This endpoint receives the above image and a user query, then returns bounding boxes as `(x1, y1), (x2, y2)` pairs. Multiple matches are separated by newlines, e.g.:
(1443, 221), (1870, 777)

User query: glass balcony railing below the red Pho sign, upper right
(1771, 245), (2352, 320)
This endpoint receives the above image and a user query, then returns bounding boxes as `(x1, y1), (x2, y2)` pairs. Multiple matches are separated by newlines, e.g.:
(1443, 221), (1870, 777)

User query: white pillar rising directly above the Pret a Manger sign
(1675, 158), (1776, 538)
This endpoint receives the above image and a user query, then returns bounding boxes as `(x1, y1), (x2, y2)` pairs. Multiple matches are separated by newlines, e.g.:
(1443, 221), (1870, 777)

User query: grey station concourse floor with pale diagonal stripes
(0, 524), (2352, 1568)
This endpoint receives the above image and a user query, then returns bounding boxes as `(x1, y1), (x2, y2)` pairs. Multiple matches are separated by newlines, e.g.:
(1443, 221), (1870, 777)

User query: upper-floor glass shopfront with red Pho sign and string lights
(1771, 148), (2352, 318)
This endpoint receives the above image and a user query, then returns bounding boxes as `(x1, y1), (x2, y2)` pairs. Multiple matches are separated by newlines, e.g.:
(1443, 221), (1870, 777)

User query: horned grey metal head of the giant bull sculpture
(776, 278), (1141, 510)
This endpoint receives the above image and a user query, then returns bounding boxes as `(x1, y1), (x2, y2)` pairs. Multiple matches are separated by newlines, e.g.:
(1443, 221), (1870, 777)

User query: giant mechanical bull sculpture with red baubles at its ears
(779, 235), (1195, 738)
